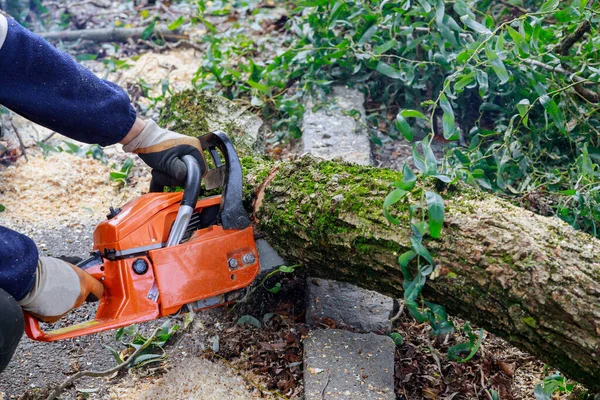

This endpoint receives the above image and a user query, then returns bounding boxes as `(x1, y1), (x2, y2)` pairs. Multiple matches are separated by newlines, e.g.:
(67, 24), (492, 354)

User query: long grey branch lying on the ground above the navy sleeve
(39, 25), (187, 42)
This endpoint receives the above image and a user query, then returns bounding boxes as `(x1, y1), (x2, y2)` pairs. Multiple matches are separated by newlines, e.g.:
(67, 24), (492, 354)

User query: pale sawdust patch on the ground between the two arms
(0, 153), (149, 228)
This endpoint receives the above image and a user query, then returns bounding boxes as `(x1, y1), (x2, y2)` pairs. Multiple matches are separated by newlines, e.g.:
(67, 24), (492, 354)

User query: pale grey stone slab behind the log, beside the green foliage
(302, 86), (372, 165)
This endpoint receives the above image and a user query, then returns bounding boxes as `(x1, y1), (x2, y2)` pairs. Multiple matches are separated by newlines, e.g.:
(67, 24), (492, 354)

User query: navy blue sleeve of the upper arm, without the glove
(0, 19), (136, 146)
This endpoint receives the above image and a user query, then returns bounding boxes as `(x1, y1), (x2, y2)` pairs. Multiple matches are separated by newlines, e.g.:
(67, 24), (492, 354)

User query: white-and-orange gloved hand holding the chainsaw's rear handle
(18, 257), (104, 323)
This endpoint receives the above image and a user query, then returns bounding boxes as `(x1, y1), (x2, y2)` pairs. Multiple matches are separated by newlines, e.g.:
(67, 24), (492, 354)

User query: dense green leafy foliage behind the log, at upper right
(196, 0), (600, 236)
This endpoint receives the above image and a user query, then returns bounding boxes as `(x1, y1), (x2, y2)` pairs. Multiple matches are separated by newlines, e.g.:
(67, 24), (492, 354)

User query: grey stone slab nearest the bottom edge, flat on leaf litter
(304, 329), (395, 400)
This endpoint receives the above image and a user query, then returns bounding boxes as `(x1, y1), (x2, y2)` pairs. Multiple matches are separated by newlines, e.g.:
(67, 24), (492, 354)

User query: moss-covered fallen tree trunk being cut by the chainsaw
(242, 157), (600, 390)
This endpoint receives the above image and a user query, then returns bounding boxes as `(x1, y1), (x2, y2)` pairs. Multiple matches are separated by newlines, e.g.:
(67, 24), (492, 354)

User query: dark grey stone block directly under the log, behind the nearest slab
(306, 278), (395, 333)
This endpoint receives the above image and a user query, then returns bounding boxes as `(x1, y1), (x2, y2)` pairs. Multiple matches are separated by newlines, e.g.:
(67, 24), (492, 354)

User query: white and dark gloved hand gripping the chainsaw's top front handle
(123, 120), (206, 187)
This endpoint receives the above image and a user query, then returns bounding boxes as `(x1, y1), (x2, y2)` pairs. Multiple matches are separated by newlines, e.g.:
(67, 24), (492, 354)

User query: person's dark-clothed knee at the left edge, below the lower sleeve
(0, 289), (24, 373)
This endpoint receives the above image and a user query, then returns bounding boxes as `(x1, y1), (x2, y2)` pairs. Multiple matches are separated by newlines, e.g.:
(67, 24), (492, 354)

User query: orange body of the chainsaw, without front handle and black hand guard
(25, 130), (259, 341)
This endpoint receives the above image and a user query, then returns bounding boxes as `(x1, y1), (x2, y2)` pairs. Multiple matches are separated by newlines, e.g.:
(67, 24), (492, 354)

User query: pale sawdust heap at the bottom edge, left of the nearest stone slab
(111, 358), (269, 400)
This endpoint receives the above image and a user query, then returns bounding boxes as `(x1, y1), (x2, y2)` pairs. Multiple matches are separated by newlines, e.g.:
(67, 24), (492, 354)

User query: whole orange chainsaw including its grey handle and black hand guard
(25, 132), (260, 342)
